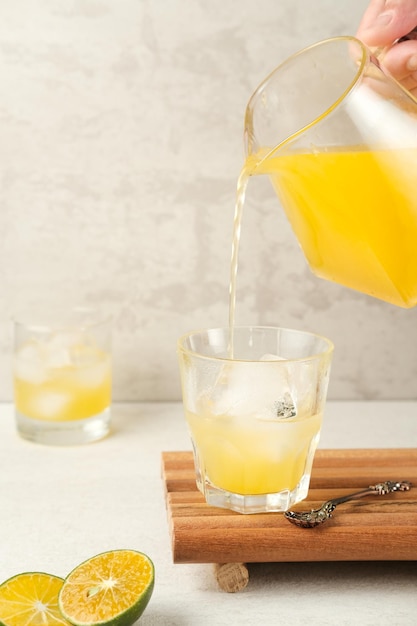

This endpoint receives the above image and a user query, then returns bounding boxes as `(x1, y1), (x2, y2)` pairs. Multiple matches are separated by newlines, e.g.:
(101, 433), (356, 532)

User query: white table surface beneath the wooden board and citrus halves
(0, 402), (417, 626)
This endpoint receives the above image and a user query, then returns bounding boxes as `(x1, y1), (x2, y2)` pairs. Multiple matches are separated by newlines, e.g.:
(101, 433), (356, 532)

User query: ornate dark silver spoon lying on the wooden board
(284, 480), (411, 528)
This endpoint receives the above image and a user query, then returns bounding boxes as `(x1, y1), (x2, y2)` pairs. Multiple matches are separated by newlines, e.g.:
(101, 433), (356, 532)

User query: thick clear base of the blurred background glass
(15, 408), (111, 446)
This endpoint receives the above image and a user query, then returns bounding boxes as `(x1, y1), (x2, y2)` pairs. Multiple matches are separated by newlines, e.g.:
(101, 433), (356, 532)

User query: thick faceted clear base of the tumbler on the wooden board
(197, 474), (310, 513)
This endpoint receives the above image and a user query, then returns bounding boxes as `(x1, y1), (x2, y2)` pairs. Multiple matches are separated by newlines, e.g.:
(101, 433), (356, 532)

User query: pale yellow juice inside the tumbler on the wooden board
(186, 402), (322, 495)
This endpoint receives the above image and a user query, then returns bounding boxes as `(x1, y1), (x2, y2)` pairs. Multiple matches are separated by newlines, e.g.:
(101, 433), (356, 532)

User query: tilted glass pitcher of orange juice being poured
(245, 37), (417, 308)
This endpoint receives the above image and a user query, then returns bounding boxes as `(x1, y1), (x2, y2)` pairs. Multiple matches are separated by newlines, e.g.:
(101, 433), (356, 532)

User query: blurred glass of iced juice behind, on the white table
(13, 309), (111, 445)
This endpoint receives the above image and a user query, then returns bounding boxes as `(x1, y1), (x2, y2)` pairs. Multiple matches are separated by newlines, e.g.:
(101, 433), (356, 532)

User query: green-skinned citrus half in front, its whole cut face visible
(58, 550), (155, 626)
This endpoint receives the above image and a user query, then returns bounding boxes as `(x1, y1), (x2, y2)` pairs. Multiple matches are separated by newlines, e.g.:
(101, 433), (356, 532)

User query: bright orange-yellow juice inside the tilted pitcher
(252, 147), (417, 307)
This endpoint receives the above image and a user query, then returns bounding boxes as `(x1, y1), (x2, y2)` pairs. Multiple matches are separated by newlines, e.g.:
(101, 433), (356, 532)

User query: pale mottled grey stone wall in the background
(0, 0), (417, 400)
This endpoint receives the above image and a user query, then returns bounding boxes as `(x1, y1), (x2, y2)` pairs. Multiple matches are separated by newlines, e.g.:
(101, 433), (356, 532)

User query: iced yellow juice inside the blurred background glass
(14, 341), (111, 422)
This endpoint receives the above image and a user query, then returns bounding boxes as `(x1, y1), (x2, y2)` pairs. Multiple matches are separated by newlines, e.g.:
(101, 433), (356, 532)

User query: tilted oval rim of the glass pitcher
(245, 35), (372, 160)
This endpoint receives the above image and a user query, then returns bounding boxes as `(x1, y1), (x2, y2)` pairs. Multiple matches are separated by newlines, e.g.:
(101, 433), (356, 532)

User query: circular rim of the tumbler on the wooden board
(177, 325), (334, 363)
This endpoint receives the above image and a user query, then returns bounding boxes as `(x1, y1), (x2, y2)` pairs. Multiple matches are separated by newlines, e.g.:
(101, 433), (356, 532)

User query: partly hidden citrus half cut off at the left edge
(0, 572), (70, 626)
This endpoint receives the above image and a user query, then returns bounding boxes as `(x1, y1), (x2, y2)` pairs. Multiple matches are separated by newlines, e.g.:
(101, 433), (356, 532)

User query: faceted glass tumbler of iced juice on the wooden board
(178, 327), (333, 513)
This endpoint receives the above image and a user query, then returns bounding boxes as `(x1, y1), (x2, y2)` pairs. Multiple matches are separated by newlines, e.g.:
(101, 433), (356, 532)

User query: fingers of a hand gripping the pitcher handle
(356, 0), (417, 96)
